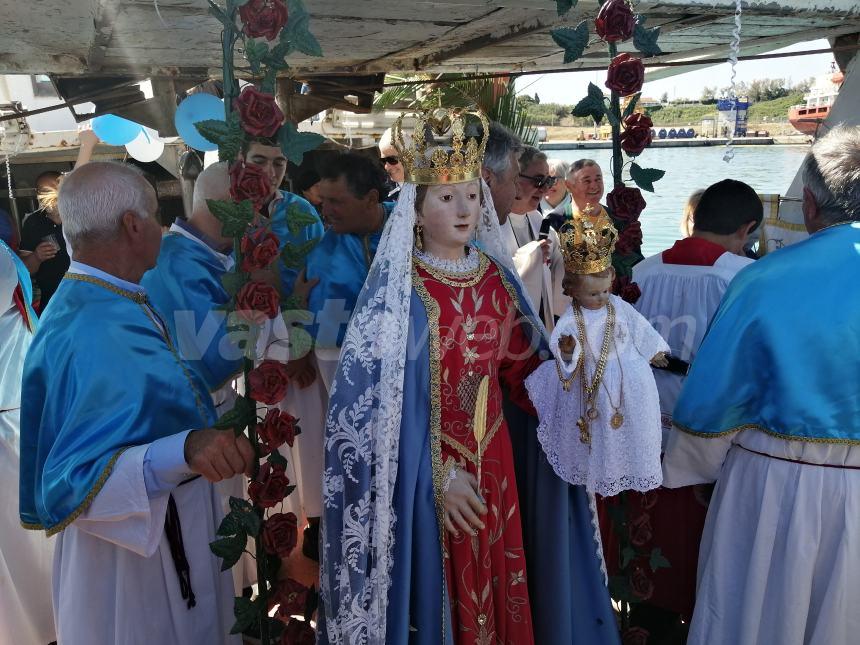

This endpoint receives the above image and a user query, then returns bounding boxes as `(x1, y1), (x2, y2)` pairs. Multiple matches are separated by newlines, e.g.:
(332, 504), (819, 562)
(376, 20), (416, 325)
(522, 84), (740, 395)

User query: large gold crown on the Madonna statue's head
(391, 108), (490, 185)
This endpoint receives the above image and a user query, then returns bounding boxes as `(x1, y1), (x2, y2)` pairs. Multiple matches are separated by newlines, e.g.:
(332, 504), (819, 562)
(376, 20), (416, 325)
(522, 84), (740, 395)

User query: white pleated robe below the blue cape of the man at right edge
(663, 429), (860, 645)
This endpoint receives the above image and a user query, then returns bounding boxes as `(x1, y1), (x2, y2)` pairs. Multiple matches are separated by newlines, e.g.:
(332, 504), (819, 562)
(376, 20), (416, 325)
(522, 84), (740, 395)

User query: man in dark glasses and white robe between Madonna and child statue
(501, 146), (569, 330)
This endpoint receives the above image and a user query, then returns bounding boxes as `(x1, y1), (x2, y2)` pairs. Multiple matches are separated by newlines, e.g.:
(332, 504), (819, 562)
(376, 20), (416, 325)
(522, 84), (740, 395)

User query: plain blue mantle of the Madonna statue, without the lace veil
(317, 254), (619, 645)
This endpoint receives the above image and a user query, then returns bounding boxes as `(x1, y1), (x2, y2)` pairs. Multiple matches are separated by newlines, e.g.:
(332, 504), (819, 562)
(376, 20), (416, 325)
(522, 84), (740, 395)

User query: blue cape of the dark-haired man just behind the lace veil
(306, 202), (394, 348)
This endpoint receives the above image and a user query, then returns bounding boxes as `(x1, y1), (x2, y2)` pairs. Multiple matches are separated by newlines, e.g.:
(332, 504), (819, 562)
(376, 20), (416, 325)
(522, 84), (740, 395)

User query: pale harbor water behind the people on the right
(546, 146), (809, 257)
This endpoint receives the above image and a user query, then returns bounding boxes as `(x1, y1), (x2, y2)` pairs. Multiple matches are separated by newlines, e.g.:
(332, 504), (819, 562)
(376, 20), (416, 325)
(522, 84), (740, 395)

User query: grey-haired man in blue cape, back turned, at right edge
(663, 126), (860, 645)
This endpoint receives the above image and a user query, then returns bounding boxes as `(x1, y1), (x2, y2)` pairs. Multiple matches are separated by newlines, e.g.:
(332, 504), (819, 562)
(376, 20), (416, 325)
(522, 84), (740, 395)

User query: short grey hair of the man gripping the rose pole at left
(59, 161), (158, 250)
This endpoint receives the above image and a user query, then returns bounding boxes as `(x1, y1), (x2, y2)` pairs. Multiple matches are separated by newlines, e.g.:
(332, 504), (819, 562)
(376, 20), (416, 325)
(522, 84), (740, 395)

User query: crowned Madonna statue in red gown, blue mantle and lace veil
(319, 110), (617, 645)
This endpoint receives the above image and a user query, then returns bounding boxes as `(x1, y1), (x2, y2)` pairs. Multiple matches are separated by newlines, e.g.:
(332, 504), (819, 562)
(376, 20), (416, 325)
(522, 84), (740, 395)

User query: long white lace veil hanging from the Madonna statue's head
(321, 180), (546, 645)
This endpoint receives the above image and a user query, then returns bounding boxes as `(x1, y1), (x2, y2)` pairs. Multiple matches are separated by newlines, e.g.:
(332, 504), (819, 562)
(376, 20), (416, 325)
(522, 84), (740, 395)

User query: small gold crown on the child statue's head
(558, 211), (618, 275)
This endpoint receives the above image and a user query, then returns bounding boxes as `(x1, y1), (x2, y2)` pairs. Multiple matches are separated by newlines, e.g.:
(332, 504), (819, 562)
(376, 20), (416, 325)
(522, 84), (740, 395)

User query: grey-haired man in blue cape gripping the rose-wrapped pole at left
(20, 163), (253, 645)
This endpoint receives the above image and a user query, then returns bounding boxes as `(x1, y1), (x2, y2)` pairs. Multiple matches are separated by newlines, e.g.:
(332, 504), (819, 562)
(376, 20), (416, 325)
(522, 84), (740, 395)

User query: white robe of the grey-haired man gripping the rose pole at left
(53, 445), (241, 645)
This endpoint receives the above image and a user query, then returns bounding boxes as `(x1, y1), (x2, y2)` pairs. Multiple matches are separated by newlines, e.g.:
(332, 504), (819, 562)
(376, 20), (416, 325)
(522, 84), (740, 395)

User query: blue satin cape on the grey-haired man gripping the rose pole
(20, 274), (216, 535)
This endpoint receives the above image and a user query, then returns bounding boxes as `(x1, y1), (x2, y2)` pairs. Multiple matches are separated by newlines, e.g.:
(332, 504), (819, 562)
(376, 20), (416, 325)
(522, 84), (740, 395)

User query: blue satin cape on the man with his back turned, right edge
(673, 223), (860, 443)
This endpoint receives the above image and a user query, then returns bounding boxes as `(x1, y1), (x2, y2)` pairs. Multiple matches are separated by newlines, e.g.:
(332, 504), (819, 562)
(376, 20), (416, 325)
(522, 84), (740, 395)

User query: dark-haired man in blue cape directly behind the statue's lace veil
(278, 153), (394, 559)
